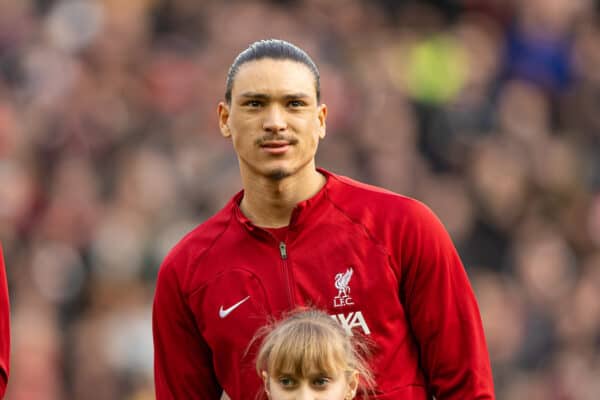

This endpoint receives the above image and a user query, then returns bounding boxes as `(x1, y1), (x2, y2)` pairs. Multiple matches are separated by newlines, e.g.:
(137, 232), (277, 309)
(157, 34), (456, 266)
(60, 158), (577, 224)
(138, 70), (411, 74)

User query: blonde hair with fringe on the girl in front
(253, 309), (375, 399)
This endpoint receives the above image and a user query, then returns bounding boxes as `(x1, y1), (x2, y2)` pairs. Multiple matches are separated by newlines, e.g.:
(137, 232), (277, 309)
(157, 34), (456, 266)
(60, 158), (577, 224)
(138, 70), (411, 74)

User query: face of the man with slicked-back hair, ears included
(218, 58), (327, 179)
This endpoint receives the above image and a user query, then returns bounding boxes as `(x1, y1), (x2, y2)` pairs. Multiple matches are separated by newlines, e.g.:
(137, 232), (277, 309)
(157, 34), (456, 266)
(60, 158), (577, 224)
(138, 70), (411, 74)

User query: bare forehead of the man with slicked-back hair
(232, 58), (315, 96)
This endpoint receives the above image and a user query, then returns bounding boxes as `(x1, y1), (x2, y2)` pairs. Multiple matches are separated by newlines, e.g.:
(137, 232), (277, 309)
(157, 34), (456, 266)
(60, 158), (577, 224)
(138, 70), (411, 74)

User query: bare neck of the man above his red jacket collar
(240, 168), (326, 228)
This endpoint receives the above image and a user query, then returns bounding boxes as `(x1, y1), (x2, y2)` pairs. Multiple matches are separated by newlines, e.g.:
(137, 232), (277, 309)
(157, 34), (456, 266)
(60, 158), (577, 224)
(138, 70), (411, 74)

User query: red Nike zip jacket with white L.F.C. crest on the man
(153, 169), (494, 400)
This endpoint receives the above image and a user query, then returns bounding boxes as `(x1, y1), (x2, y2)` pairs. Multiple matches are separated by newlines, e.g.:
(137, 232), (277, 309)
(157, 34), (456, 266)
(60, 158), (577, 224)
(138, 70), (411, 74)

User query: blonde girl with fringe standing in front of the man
(256, 309), (373, 400)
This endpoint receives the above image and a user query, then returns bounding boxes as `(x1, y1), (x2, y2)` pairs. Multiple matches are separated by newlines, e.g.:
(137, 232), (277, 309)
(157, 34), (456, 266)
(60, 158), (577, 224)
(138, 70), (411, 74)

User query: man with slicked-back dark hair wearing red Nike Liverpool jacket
(153, 40), (494, 400)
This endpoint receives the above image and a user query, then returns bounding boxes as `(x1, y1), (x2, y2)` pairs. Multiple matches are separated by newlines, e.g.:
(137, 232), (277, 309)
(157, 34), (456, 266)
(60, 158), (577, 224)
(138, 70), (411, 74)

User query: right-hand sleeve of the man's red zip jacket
(401, 203), (494, 400)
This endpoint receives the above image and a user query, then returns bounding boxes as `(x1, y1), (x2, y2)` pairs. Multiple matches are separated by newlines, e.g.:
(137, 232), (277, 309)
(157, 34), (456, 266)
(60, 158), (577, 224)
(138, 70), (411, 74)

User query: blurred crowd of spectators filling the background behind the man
(0, 0), (600, 400)
